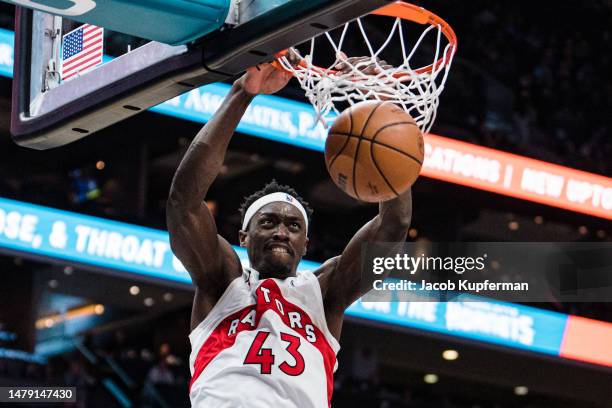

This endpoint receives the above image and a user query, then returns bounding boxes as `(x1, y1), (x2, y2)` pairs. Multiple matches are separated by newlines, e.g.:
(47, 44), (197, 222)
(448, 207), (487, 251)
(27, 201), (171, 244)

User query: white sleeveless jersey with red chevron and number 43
(189, 269), (340, 408)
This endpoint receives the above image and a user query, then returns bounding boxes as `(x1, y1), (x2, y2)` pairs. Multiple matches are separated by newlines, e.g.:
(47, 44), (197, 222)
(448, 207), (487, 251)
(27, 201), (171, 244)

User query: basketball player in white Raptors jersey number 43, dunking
(167, 58), (412, 408)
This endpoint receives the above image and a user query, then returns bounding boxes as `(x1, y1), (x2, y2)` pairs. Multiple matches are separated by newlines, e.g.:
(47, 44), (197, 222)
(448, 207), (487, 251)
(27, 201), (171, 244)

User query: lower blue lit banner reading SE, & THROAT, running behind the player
(0, 198), (567, 355)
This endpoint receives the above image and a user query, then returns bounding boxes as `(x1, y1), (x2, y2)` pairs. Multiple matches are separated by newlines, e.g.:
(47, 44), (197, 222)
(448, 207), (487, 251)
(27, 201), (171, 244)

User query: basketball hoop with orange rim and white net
(277, 1), (457, 133)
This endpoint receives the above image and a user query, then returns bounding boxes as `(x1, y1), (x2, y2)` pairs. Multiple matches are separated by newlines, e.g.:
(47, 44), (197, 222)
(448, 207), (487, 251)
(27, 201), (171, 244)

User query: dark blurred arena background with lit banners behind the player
(0, 0), (612, 408)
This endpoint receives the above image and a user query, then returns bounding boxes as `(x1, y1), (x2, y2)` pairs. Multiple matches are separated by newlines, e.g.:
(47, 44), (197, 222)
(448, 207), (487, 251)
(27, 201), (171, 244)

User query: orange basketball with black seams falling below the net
(325, 101), (424, 202)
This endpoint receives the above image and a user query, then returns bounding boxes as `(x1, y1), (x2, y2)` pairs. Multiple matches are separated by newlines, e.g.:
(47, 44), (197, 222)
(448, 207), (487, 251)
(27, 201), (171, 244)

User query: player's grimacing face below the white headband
(240, 202), (308, 278)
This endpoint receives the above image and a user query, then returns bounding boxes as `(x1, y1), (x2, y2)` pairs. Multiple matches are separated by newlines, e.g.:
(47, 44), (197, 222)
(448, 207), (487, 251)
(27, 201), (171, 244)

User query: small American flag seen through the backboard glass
(61, 24), (104, 81)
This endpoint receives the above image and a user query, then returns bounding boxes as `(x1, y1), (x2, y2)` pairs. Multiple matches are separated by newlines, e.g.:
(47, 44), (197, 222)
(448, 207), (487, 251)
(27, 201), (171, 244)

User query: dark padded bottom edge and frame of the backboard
(11, 0), (389, 150)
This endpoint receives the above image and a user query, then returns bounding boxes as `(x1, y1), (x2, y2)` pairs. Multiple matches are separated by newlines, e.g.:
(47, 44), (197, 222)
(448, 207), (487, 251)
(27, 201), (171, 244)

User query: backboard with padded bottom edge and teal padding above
(8, 0), (390, 150)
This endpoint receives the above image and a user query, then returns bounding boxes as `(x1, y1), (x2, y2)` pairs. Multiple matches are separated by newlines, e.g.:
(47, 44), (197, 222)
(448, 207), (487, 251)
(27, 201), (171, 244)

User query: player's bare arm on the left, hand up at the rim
(166, 64), (290, 327)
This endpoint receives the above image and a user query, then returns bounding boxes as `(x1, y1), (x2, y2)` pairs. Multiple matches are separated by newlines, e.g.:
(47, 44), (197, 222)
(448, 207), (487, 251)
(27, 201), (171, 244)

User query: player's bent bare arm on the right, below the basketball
(318, 189), (412, 337)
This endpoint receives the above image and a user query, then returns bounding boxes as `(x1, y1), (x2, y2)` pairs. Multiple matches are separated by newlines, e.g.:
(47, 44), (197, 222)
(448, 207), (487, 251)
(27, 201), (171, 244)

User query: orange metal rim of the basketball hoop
(273, 1), (457, 77)
